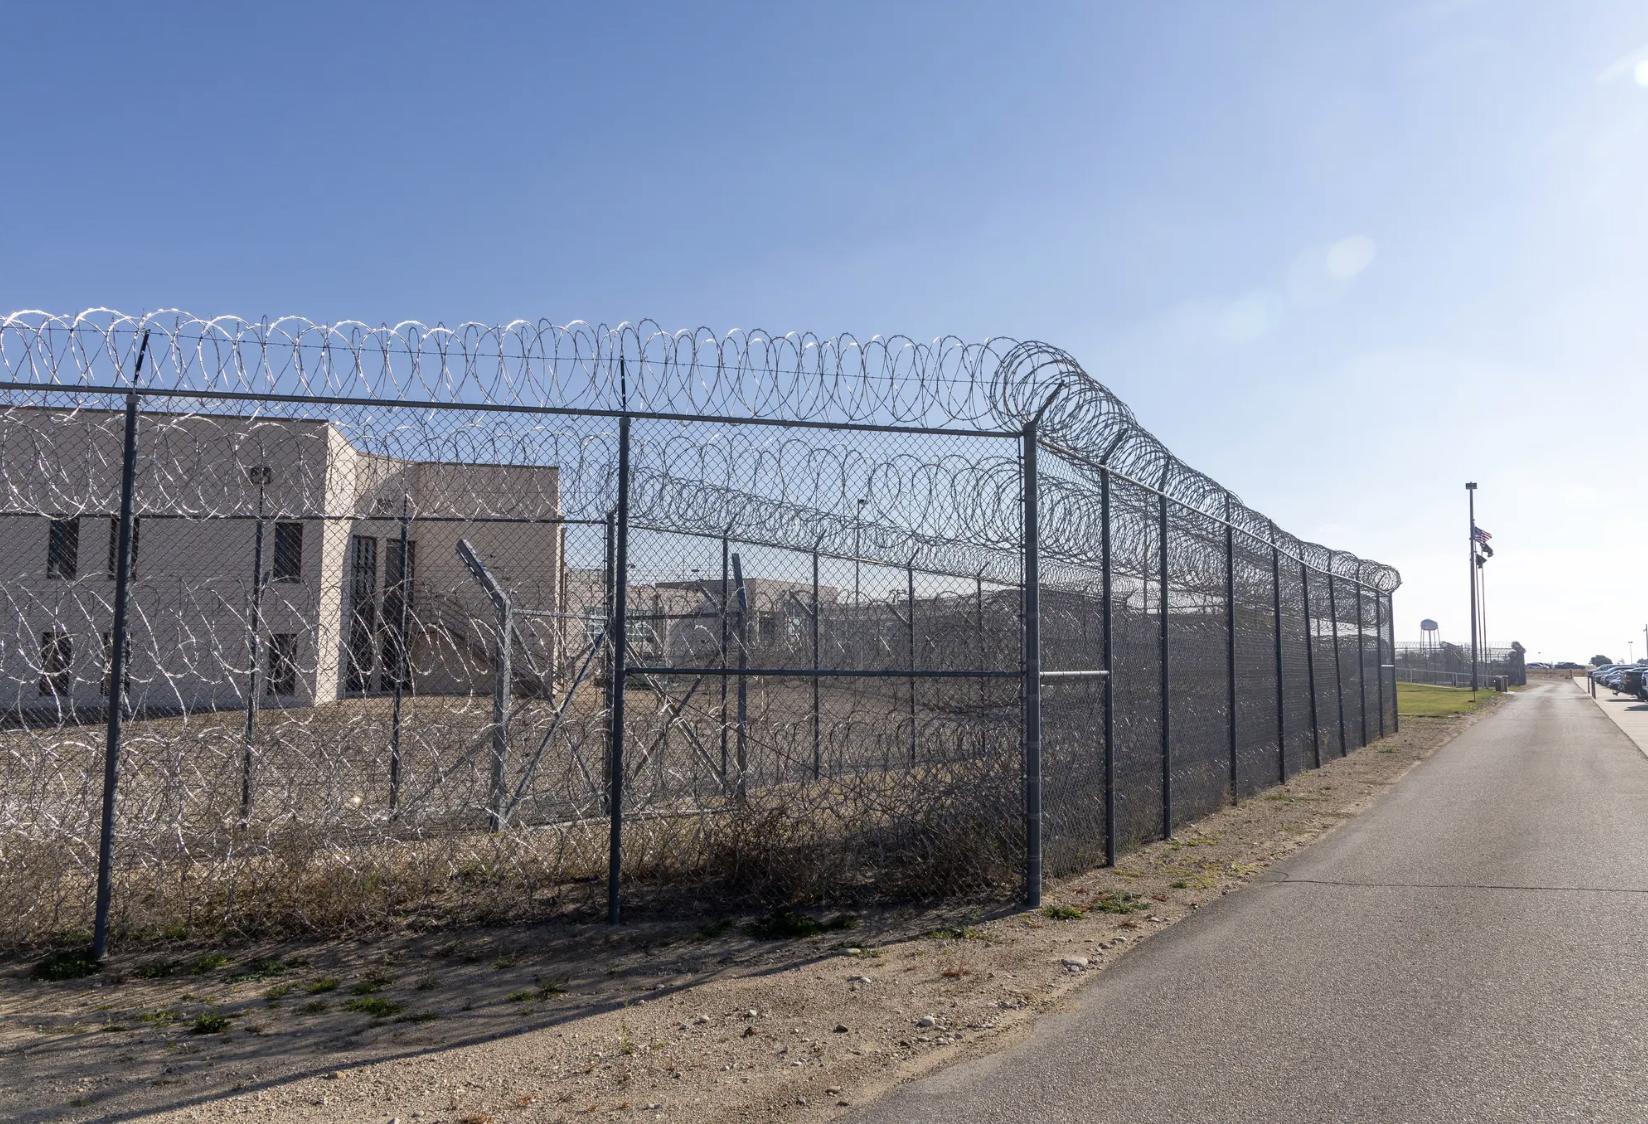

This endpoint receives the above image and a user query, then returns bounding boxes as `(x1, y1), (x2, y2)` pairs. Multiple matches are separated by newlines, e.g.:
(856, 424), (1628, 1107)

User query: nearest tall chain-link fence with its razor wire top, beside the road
(0, 311), (1399, 944)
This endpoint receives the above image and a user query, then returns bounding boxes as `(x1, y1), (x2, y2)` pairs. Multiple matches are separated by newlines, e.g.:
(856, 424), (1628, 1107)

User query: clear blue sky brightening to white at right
(0, 0), (1648, 659)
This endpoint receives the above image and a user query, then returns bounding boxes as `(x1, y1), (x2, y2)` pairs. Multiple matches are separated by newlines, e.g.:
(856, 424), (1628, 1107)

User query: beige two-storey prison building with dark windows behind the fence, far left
(0, 405), (564, 714)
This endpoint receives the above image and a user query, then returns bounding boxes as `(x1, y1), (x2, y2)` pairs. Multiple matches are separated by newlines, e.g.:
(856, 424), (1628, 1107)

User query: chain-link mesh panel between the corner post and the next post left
(623, 420), (1023, 902)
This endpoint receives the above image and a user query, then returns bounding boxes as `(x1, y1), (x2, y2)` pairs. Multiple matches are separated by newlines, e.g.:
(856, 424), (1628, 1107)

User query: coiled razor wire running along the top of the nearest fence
(0, 308), (1401, 592)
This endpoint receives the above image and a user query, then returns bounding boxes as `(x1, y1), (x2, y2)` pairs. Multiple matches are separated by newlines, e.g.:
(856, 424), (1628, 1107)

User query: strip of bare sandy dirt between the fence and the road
(0, 700), (1498, 1124)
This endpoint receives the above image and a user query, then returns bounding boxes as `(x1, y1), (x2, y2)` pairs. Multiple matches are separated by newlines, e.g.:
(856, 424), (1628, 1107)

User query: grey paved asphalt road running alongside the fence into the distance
(852, 682), (1648, 1124)
